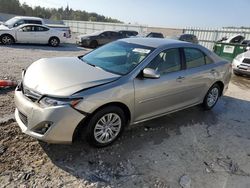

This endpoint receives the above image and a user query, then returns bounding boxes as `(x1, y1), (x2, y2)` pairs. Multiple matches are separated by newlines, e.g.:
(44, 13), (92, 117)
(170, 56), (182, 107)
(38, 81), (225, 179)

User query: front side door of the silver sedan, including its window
(134, 48), (186, 121)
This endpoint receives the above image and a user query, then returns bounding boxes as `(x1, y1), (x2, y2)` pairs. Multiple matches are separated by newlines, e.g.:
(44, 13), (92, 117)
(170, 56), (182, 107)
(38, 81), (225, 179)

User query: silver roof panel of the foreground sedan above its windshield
(120, 38), (188, 48)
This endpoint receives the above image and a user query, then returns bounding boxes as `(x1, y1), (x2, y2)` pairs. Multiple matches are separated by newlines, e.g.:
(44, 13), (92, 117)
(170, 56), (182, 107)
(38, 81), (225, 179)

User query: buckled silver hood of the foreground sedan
(23, 57), (120, 96)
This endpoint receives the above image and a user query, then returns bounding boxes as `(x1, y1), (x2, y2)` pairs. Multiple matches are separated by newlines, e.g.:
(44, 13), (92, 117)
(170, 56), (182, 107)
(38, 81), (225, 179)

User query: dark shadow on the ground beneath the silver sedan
(40, 96), (250, 183)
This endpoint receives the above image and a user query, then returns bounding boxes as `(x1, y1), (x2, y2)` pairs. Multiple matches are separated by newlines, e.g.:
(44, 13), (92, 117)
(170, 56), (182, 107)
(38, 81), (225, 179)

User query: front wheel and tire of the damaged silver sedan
(85, 106), (126, 147)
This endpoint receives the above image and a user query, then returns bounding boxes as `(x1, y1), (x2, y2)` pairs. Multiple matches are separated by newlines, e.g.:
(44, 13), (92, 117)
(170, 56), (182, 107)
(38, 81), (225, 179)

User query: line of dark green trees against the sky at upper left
(0, 0), (122, 23)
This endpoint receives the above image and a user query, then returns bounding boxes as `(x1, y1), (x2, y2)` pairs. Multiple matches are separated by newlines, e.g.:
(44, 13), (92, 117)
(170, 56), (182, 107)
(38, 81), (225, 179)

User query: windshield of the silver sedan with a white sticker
(81, 41), (153, 75)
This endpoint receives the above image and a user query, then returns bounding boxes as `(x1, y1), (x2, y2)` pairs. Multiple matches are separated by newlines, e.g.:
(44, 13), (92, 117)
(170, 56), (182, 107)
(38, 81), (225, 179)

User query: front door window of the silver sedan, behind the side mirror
(147, 48), (181, 75)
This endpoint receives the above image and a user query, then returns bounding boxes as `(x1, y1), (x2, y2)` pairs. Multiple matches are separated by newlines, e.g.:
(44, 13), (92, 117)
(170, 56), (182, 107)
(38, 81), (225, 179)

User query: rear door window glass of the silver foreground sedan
(184, 48), (206, 69)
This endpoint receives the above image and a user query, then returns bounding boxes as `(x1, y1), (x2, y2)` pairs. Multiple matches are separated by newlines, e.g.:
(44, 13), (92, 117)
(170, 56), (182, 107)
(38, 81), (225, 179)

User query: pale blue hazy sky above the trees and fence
(20, 0), (250, 28)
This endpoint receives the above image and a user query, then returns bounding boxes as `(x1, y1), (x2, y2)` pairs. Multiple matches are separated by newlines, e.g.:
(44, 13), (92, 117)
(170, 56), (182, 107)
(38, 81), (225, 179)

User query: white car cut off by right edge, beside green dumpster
(232, 51), (250, 76)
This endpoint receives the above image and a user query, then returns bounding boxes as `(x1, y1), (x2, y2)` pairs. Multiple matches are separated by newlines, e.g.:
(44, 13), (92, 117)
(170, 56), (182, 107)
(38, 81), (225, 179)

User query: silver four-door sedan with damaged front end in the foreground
(15, 38), (231, 147)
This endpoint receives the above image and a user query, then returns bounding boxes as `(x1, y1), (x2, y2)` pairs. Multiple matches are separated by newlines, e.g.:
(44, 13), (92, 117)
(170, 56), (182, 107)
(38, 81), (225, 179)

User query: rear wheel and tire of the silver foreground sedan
(203, 84), (221, 110)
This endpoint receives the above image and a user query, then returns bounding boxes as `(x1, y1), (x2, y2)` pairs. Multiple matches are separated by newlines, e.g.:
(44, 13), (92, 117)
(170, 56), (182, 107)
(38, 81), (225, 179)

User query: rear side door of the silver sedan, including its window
(182, 48), (216, 106)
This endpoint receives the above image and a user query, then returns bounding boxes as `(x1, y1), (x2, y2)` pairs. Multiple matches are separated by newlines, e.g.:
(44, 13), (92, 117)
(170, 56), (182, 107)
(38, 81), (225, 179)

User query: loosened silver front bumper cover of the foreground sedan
(15, 91), (85, 143)
